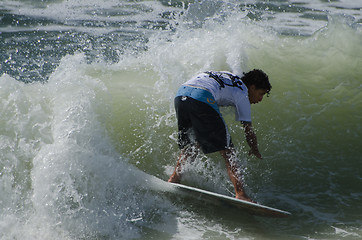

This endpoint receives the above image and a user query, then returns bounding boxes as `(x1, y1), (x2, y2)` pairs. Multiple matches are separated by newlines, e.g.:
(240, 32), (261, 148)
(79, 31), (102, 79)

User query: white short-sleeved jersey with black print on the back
(183, 72), (251, 122)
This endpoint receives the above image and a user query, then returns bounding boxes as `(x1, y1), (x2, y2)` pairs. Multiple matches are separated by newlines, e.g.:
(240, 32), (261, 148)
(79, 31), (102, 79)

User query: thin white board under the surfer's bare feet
(169, 183), (291, 217)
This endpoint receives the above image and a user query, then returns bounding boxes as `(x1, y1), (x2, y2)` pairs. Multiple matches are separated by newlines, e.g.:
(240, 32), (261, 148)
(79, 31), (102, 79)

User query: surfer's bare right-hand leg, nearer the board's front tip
(220, 149), (253, 202)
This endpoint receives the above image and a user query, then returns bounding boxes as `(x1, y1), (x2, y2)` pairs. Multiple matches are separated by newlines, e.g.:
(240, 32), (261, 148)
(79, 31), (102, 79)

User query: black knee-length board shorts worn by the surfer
(175, 96), (232, 154)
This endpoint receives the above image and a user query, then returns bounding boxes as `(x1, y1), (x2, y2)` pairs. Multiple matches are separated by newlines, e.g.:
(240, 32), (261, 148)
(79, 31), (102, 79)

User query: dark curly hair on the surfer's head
(241, 69), (271, 95)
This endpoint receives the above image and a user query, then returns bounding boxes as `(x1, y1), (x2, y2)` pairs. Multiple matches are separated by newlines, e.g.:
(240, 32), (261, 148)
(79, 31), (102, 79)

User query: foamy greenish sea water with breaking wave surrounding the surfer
(0, 0), (362, 240)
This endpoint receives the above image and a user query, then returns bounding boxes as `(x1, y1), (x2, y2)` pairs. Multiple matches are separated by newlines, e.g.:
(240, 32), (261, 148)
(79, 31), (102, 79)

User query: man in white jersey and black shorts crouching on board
(168, 69), (271, 201)
